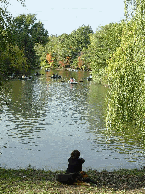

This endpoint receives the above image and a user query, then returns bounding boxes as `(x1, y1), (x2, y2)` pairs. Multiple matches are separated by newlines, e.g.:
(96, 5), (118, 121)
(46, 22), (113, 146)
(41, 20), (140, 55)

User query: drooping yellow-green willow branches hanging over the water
(106, 1), (145, 139)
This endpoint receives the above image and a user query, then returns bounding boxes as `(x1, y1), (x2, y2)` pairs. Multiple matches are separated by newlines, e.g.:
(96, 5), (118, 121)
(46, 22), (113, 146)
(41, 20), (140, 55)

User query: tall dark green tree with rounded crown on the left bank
(12, 14), (48, 68)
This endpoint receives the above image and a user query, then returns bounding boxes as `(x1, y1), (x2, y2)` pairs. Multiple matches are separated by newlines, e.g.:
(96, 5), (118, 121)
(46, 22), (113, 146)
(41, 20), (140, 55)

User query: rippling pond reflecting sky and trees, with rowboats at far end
(0, 70), (145, 171)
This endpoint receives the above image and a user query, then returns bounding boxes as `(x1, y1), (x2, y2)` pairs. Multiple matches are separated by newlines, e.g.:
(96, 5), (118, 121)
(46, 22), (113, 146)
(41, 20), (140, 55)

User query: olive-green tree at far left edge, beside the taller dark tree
(0, 0), (25, 81)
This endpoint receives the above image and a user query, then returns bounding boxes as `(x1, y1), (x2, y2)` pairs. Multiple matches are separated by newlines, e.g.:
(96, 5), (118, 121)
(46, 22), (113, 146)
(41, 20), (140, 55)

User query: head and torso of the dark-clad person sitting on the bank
(66, 150), (85, 173)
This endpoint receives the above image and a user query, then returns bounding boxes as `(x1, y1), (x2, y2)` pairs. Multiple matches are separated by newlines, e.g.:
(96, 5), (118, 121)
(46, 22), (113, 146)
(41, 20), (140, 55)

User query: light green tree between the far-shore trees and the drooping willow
(82, 21), (124, 82)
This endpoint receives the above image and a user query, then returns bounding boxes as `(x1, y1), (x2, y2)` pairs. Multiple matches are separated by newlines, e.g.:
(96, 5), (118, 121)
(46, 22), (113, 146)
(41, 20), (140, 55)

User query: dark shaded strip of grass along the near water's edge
(0, 167), (145, 191)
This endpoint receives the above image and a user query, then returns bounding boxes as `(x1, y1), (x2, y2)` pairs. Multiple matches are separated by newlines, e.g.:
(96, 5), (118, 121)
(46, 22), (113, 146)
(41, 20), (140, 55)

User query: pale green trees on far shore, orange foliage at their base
(42, 25), (93, 67)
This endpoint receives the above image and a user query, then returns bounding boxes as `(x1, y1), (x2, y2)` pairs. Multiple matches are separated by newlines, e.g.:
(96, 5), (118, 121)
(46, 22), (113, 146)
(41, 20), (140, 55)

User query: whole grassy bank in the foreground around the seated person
(0, 167), (145, 194)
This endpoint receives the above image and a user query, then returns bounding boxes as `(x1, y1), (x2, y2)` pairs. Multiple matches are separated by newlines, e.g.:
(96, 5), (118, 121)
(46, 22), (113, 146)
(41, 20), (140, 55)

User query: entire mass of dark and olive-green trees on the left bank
(0, 0), (48, 81)
